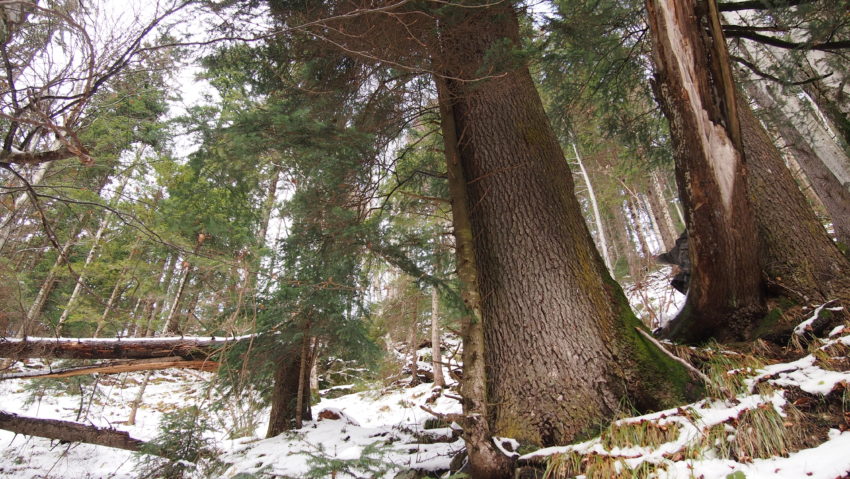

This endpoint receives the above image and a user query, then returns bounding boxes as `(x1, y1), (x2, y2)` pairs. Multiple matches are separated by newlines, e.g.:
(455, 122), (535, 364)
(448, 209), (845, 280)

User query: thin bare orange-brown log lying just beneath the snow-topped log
(0, 356), (219, 381)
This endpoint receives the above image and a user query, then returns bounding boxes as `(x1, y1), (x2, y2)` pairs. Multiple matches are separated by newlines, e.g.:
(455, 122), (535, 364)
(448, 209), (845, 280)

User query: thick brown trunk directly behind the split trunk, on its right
(738, 100), (850, 302)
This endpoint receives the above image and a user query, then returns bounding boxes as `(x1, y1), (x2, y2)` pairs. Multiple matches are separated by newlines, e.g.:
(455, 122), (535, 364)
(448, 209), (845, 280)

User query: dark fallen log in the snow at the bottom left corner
(0, 411), (156, 452)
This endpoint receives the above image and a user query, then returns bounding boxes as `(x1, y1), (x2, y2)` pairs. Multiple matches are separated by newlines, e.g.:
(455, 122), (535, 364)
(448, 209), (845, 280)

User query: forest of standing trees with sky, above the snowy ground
(0, 0), (850, 477)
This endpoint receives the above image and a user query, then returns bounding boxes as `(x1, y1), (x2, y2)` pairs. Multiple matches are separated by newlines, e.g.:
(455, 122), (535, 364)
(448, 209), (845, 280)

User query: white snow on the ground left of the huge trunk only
(0, 350), (463, 479)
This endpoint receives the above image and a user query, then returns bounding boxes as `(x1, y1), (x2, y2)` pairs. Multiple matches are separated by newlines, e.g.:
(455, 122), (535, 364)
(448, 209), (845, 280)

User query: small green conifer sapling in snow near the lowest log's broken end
(138, 406), (221, 479)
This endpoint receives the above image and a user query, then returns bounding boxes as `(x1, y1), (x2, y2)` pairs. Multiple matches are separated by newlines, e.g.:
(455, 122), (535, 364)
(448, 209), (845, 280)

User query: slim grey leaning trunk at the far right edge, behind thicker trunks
(747, 82), (850, 246)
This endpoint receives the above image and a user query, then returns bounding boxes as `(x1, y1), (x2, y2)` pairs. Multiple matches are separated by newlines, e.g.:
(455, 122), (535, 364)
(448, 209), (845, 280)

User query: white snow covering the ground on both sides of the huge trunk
(0, 306), (850, 479)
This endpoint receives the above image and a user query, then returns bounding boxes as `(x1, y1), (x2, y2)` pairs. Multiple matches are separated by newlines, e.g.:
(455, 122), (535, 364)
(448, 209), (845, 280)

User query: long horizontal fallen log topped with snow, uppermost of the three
(0, 335), (252, 361)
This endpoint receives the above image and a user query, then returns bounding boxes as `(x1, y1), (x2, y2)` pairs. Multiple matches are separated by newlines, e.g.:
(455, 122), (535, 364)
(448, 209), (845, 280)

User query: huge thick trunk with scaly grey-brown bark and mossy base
(440, 3), (700, 452)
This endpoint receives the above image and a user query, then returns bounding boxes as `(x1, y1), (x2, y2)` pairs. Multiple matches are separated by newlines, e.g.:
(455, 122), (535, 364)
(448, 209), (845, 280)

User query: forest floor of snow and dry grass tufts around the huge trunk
(0, 272), (850, 479)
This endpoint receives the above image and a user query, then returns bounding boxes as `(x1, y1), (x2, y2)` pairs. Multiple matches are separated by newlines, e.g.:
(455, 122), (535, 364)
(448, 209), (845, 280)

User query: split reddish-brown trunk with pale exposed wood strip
(647, 0), (766, 342)
